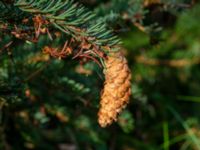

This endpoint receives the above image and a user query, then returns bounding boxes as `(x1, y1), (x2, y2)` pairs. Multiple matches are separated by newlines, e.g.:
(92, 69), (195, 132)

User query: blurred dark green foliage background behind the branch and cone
(0, 0), (200, 150)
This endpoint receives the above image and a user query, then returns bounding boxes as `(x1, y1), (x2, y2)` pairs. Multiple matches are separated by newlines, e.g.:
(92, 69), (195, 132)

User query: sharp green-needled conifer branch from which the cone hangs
(15, 0), (120, 56)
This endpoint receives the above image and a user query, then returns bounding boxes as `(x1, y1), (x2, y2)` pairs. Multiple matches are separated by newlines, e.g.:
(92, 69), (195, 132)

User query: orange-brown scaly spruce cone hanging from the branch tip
(98, 52), (131, 127)
